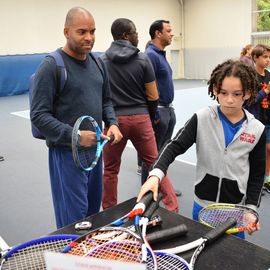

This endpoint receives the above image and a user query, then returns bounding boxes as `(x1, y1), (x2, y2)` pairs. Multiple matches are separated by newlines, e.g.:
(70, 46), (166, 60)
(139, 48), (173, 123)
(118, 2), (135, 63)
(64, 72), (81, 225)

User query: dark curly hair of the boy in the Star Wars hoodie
(208, 59), (258, 105)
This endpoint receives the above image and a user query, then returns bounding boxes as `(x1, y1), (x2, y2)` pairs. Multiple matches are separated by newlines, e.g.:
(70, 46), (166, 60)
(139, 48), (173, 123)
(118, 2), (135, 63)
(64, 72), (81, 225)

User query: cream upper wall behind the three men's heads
(0, 0), (181, 55)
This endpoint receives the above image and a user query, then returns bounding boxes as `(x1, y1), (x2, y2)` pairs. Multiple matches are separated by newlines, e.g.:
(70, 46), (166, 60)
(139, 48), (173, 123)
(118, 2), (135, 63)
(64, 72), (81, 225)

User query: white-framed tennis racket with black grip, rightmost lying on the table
(153, 218), (236, 270)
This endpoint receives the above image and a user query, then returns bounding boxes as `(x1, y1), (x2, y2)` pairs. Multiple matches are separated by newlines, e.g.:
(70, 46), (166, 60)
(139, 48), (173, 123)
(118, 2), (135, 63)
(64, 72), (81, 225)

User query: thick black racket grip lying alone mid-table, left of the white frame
(146, 224), (188, 244)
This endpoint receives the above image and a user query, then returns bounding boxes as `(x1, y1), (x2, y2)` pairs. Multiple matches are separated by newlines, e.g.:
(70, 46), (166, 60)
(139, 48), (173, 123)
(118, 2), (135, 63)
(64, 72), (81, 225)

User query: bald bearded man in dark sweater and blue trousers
(30, 7), (122, 228)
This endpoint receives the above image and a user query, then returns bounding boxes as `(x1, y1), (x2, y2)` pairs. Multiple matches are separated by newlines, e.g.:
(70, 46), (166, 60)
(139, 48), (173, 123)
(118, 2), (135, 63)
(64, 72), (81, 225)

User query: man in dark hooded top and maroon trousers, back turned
(102, 18), (178, 212)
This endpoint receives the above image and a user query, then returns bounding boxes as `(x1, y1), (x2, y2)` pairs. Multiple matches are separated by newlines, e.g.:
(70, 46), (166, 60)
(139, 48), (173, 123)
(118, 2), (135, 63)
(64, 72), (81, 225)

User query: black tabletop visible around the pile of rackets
(51, 198), (270, 270)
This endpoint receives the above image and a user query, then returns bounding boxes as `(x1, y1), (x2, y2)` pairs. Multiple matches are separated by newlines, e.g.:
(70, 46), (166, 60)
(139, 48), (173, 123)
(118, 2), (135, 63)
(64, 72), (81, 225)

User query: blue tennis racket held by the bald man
(71, 115), (113, 171)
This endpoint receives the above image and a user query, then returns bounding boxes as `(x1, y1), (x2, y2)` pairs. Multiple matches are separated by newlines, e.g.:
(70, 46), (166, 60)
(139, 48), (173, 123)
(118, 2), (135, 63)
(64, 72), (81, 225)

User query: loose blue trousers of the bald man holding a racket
(49, 148), (102, 229)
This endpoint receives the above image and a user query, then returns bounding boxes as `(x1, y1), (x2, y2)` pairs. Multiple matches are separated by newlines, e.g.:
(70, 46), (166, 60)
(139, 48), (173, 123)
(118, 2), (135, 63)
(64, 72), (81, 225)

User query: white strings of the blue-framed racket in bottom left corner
(1, 239), (72, 270)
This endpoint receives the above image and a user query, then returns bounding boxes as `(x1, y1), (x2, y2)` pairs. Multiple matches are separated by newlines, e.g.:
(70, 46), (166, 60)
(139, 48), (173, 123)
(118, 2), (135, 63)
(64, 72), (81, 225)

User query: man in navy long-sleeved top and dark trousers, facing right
(144, 20), (182, 196)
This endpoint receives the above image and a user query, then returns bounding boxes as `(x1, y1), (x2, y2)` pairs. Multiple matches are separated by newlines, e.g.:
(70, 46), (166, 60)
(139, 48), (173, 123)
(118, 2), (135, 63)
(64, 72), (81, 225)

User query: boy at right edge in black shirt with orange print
(246, 44), (270, 193)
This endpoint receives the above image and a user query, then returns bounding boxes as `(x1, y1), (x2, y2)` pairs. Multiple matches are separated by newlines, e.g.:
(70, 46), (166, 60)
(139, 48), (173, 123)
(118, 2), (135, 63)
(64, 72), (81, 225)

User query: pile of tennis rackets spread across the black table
(0, 187), (258, 270)
